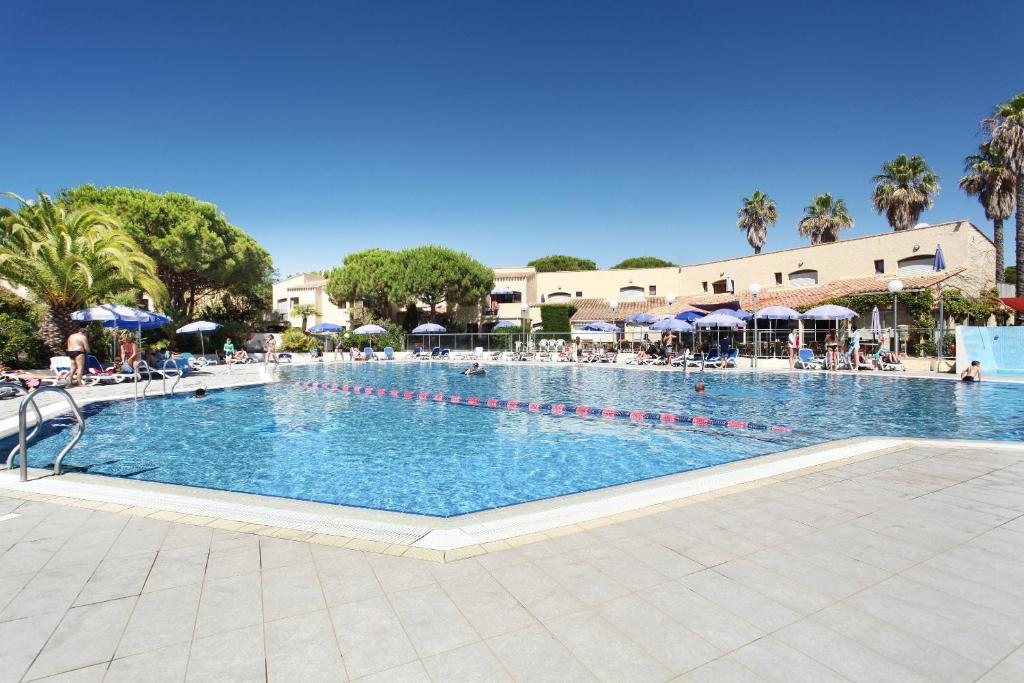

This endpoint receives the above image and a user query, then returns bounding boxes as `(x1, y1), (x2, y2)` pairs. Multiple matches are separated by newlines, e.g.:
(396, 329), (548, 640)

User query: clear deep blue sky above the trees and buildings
(0, 0), (1024, 273)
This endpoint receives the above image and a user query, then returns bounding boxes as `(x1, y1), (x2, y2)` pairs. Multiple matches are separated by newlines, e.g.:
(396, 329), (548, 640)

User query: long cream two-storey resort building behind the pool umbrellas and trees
(273, 220), (995, 331)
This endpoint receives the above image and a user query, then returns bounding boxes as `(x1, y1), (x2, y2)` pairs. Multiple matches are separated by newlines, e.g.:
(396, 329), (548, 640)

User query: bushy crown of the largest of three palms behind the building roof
(871, 155), (939, 230)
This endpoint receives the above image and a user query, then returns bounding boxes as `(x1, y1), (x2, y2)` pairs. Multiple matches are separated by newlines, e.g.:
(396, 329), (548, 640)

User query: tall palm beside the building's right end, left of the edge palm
(959, 141), (1017, 283)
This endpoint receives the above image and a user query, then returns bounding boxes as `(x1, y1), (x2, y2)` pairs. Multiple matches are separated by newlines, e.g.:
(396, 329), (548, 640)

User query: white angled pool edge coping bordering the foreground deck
(0, 437), (1024, 562)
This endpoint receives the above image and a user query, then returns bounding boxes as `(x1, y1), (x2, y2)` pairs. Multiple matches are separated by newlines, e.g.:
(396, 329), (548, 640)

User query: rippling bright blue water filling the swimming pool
(0, 362), (1024, 516)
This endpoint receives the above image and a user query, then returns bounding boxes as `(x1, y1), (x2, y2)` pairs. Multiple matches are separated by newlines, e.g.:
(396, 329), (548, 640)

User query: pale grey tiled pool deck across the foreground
(0, 445), (1024, 682)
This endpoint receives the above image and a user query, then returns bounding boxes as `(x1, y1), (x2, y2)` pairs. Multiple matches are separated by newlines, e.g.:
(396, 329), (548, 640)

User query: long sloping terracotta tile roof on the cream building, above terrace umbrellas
(650, 268), (966, 314)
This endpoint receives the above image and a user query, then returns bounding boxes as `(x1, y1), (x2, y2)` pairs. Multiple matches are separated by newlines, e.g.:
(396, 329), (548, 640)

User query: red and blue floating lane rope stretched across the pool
(295, 381), (793, 432)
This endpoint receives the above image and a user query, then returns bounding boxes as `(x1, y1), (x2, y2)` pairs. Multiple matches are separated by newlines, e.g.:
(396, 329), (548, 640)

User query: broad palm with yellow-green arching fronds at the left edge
(0, 193), (167, 354)
